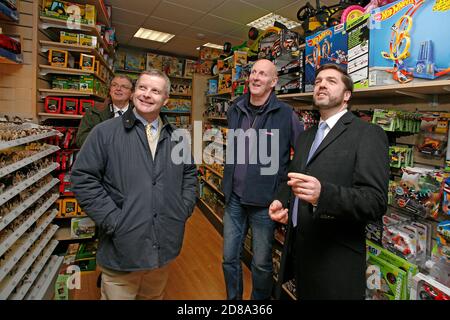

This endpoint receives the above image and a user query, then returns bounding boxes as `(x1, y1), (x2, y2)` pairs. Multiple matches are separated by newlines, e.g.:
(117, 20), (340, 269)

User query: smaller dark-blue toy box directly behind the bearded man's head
(305, 24), (348, 92)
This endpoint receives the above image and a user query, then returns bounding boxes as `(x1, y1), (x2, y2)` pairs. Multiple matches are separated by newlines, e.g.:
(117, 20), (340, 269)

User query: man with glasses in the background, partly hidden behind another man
(76, 75), (133, 148)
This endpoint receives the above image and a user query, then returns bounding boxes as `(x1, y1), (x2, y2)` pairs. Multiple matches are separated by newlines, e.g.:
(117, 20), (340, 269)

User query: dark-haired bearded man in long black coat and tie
(269, 64), (389, 300)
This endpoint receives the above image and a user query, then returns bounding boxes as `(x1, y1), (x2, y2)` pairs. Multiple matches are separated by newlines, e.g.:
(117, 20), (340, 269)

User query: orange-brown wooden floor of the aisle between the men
(166, 207), (251, 300)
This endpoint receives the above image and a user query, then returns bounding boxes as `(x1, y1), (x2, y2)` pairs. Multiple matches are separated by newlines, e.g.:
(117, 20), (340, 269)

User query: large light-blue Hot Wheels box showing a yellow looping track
(369, 0), (450, 86)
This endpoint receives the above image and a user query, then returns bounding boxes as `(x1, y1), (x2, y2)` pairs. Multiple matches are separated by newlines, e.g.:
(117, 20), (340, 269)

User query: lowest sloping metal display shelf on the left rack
(25, 255), (64, 300)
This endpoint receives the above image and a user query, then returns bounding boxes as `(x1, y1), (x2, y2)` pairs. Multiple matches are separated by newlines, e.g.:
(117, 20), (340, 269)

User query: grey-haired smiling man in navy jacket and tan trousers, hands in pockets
(71, 70), (197, 299)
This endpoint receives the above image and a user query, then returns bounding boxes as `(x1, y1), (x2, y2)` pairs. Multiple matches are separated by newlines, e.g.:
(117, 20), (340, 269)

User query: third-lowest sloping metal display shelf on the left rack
(0, 216), (58, 282)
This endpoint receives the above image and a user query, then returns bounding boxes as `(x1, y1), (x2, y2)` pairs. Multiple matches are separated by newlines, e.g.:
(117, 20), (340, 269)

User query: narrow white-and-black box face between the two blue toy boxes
(345, 14), (370, 89)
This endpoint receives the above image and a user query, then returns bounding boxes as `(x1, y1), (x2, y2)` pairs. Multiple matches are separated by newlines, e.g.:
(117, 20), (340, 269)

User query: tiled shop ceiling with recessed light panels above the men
(105, 0), (339, 58)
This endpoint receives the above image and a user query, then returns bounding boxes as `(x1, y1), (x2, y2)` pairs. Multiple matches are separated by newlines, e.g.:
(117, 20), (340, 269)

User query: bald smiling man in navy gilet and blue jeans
(222, 60), (303, 300)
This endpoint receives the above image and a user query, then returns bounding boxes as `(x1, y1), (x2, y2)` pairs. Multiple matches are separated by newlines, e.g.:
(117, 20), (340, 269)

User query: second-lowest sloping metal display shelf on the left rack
(0, 237), (58, 300)
